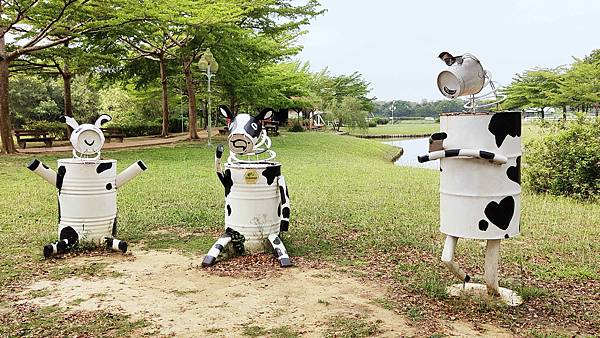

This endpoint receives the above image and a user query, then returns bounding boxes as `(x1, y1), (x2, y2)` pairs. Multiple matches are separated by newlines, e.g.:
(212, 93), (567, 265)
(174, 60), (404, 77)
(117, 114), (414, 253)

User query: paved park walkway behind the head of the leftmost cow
(17, 130), (208, 154)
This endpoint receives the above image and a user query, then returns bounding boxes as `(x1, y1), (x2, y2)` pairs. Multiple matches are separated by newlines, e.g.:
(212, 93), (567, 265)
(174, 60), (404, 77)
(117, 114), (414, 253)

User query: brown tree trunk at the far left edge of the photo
(0, 35), (16, 154)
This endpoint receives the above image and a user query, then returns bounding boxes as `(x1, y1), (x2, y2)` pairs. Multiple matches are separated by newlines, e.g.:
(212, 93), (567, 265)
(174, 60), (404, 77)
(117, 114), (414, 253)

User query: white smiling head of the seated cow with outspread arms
(60, 114), (112, 159)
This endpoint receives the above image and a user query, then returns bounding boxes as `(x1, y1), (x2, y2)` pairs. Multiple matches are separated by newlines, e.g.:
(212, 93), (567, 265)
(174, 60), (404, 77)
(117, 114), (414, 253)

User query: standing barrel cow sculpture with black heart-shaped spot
(418, 53), (521, 305)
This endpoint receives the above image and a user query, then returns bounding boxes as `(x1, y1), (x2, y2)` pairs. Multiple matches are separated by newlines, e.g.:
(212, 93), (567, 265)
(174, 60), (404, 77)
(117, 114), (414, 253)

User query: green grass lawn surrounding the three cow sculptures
(0, 130), (600, 332)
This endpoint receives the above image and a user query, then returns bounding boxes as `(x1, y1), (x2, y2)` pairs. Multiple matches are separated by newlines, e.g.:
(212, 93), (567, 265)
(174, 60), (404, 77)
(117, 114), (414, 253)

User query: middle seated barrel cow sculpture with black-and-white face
(202, 106), (292, 267)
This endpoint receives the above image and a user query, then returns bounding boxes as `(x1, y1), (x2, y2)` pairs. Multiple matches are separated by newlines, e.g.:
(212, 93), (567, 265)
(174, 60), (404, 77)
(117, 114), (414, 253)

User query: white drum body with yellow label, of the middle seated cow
(225, 162), (281, 252)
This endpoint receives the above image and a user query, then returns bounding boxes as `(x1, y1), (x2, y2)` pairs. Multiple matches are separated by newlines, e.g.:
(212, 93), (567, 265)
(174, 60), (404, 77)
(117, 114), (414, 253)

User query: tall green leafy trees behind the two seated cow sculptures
(0, 0), (372, 153)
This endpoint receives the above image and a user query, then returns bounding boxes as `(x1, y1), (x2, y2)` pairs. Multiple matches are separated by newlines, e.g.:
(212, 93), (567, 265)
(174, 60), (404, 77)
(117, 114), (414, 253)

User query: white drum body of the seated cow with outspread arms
(57, 159), (117, 244)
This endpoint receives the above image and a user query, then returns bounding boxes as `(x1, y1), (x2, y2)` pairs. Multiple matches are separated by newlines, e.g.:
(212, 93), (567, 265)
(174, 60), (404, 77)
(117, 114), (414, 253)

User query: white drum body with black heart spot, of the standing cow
(440, 112), (521, 239)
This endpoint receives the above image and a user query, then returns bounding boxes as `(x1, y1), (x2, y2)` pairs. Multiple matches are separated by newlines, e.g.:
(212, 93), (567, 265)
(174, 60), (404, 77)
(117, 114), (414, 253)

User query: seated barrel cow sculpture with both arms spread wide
(27, 115), (146, 258)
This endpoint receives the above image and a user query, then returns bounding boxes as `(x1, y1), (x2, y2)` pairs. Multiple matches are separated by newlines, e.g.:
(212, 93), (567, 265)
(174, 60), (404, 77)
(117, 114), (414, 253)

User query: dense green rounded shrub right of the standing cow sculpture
(523, 119), (600, 199)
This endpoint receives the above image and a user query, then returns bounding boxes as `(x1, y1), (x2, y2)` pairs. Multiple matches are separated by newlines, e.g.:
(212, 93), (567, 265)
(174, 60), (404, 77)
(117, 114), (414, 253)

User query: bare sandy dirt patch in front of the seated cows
(16, 250), (508, 337)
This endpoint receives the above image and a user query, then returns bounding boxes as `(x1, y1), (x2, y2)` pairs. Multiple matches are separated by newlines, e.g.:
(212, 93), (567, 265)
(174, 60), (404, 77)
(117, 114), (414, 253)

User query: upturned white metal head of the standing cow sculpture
(437, 54), (485, 99)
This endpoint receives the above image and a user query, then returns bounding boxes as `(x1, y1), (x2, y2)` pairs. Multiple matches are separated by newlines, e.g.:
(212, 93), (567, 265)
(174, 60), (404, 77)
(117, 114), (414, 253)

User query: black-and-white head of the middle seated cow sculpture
(219, 105), (273, 155)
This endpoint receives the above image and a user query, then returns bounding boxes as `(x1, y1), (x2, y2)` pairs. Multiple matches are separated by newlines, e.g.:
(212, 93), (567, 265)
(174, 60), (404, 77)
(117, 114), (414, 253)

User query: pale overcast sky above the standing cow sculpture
(299, 0), (600, 101)
